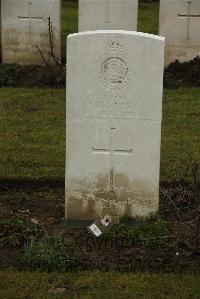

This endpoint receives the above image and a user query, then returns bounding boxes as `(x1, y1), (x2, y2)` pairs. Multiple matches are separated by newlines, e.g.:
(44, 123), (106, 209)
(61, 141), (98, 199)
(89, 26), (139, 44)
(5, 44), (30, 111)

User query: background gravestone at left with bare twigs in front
(1, 0), (61, 64)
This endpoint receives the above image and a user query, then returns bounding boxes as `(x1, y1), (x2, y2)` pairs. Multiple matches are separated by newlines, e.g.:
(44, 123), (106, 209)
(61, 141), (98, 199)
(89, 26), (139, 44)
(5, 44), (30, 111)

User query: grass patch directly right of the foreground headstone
(161, 88), (200, 180)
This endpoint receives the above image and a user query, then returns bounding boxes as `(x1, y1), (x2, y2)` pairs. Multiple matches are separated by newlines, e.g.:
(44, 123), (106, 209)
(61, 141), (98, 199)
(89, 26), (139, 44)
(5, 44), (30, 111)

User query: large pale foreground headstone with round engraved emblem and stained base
(66, 30), (164, 220)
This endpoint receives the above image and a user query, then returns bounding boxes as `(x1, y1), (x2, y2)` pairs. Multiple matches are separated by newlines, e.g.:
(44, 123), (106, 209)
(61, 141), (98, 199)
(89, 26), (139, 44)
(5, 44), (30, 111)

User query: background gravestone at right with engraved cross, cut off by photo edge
(159, 0), (200, 65)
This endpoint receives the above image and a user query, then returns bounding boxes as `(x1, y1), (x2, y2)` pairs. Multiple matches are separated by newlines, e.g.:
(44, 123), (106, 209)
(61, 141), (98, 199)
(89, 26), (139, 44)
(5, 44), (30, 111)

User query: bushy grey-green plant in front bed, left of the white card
(23, 234), (78, 272)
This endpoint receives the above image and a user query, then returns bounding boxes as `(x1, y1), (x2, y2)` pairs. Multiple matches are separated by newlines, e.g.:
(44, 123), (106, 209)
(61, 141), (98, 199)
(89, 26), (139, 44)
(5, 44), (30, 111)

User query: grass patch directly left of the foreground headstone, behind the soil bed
(0, 89), (65, 179)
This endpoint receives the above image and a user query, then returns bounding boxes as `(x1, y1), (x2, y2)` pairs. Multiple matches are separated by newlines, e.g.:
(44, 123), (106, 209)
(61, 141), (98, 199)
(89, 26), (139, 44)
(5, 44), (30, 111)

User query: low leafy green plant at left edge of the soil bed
(0, 218), (41, 247)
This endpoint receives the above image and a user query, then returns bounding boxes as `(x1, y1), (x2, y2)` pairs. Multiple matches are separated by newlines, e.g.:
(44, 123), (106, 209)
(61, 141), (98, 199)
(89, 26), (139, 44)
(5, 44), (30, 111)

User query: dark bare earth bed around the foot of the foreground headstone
(0, 181), (200, 272)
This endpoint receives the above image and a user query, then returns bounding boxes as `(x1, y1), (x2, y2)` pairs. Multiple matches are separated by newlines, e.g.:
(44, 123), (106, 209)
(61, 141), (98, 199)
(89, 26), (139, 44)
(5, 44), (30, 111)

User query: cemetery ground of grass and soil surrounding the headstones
(0, 1), (200, 299)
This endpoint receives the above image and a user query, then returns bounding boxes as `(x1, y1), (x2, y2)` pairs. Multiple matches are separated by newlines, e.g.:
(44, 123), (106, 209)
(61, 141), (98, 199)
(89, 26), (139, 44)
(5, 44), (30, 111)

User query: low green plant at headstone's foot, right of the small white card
(102, 216), (170, 248)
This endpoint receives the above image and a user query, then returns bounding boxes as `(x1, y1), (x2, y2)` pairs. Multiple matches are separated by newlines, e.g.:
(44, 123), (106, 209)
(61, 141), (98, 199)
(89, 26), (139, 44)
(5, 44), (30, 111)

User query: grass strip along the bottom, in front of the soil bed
(0, 272), (200, 299)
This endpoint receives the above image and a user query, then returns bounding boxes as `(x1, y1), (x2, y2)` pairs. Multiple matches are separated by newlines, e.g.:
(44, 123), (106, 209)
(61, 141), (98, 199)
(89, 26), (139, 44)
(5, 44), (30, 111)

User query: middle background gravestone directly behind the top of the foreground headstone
(78, 0), (138, 32)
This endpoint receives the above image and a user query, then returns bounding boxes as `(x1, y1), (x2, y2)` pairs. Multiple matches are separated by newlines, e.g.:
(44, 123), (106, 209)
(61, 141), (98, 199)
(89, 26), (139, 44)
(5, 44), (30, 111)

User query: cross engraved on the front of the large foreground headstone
(92, 127), (133, 192)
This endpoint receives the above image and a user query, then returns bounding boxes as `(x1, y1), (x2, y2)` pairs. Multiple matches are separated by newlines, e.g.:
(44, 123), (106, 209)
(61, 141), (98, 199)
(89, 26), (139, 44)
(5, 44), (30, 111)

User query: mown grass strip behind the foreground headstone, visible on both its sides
(0, 88), (200, 180)
